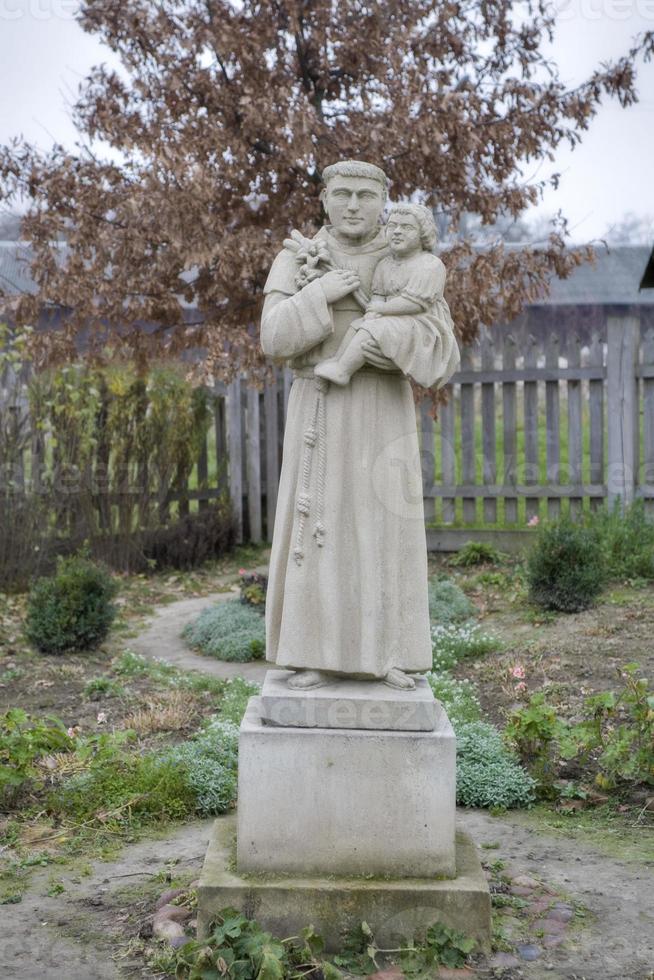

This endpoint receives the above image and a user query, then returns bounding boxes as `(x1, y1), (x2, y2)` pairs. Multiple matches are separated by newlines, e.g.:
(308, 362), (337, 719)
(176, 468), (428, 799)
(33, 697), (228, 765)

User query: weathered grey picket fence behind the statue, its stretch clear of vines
(216, 316), (654, 541)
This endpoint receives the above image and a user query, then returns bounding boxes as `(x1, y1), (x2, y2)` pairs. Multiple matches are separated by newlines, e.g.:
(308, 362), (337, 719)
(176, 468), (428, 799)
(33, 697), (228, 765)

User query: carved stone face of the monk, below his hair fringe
(321, 176), (384, 242)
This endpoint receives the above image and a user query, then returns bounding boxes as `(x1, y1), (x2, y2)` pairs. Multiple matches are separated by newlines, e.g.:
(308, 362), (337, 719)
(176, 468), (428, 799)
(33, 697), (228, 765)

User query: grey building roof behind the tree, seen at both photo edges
(0, 242), (654, 306)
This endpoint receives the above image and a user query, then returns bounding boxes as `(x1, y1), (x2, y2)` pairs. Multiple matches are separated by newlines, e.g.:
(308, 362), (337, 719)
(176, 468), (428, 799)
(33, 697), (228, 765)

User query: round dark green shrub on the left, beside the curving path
(25, 557), (117, 654)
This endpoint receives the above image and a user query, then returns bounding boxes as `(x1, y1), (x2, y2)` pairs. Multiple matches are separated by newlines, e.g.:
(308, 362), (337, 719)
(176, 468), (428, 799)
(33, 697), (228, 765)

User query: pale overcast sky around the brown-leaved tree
(0, 0), (654, 241)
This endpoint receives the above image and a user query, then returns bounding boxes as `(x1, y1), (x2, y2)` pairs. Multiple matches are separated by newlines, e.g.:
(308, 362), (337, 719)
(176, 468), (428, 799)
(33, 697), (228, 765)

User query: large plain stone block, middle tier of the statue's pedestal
(237, 697), (456, 877)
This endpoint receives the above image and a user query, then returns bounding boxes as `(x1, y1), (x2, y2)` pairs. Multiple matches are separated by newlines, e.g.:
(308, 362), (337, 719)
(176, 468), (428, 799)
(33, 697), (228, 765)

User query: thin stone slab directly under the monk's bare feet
(261, 670), (443, 732)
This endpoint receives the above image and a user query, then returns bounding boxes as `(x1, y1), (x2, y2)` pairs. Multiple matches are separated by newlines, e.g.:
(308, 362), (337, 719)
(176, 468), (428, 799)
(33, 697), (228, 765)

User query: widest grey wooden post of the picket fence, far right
(606, 316), (640, 507)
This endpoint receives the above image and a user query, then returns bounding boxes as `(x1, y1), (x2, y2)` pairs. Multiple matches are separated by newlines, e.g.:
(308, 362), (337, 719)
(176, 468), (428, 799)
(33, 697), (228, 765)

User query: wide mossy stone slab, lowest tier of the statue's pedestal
(198, 817), (491, 952)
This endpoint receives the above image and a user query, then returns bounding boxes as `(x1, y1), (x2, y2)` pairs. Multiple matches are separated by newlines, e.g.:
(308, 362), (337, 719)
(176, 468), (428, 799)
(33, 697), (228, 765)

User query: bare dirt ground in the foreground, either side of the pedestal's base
(0, 810), (654, 980)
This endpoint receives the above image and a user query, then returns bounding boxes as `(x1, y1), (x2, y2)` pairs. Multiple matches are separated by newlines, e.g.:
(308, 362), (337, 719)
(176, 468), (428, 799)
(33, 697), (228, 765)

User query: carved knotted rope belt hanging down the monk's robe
(293, 367), (403, 565)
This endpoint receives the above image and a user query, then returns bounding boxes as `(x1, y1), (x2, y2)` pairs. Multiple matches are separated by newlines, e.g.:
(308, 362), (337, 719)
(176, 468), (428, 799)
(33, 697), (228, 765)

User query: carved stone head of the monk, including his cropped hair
(320, 160), (388, 244)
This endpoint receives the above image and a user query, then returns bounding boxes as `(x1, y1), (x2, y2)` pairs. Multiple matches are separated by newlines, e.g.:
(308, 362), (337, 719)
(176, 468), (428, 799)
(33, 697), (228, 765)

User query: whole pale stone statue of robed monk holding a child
(261, 160), (459, 689)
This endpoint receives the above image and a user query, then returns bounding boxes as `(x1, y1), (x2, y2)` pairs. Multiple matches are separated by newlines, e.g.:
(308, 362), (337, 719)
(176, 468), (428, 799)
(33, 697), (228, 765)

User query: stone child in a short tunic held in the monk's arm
(314, 204), (454, 387)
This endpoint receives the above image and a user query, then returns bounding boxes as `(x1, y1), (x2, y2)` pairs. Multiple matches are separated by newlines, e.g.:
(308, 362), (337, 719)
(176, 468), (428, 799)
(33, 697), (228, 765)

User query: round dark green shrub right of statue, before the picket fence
(527, 518), (606, 612)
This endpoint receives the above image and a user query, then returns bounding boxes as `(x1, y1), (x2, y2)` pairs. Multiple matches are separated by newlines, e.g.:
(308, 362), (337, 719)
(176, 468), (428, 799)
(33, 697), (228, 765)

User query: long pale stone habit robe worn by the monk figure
(261, 228), (458, 678)
